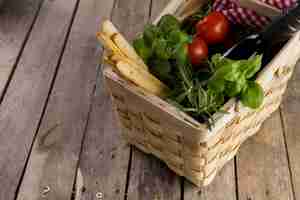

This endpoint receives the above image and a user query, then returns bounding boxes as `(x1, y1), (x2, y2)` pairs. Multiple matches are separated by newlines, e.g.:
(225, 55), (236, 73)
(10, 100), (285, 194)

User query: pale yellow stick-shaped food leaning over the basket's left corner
(97, 20), (169, 97)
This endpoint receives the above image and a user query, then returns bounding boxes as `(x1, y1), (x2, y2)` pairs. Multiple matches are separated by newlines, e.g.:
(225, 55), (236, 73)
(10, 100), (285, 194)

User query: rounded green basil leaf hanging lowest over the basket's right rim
(241, 81), (264, 109)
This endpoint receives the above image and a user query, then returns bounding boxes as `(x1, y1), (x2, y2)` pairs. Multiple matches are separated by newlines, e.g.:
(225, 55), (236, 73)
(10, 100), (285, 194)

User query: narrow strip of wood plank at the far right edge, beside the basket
(281, 63), (300, 199)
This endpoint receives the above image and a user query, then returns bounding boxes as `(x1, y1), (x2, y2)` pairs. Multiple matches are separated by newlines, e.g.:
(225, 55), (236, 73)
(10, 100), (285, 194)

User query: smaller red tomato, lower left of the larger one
(188, 37), (208, 66)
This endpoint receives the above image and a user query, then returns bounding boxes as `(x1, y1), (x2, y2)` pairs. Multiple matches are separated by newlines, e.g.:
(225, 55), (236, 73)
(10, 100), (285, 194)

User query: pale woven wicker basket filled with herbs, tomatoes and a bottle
(104, 0), (300, 186)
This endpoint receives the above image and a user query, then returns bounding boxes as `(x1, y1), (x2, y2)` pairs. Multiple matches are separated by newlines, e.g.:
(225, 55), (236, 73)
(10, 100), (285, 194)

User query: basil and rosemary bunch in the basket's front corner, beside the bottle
(170, 54), (264, 124)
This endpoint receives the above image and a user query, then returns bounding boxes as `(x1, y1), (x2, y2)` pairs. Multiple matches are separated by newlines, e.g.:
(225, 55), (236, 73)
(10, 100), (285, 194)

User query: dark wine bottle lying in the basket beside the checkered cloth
(223, 3), (300, 65)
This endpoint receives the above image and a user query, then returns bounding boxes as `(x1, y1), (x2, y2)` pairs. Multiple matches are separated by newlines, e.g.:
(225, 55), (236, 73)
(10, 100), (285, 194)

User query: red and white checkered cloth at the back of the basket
(213, 0), (297, 28)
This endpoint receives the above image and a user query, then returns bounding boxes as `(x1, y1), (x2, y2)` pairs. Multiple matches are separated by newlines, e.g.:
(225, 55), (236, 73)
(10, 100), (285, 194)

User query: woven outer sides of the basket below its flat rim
(107, 61), (293, 186)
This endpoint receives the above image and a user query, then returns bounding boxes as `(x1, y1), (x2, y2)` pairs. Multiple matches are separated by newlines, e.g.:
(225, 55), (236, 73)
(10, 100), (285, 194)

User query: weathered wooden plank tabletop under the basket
(0, 0), (300, 200)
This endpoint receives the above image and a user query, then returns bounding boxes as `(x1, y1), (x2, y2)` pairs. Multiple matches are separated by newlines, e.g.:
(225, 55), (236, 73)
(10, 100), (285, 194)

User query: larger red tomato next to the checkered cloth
(196, 11), (229, 45)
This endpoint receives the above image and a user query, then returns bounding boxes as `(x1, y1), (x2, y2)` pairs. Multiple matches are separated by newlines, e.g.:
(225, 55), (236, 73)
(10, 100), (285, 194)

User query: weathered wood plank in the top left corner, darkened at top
(0, 0), (41, 96)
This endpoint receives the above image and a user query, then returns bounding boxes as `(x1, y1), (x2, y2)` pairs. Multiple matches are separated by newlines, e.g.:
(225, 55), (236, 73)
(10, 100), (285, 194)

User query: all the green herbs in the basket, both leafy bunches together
(133, 15), (263, 125)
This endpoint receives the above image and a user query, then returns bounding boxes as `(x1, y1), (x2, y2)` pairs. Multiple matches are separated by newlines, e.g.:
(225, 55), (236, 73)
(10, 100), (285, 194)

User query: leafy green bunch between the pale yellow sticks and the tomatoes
(133, 15), (192, 89)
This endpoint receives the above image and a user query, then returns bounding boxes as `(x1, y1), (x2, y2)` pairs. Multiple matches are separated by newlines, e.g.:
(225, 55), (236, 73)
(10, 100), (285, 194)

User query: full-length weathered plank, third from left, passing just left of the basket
(18, 0), (113, 200)
